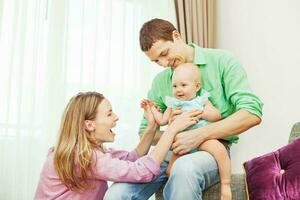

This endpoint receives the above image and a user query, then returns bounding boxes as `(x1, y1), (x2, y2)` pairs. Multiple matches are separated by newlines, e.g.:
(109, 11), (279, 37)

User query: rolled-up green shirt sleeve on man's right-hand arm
(222, 53), (263, 118)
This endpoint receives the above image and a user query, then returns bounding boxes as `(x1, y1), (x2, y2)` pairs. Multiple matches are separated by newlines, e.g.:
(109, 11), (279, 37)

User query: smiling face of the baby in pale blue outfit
(172, 73), (200, 101)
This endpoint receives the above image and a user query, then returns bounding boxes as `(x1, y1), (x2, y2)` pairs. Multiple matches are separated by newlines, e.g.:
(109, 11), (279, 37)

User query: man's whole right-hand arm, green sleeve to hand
(172, 53), (263, 154)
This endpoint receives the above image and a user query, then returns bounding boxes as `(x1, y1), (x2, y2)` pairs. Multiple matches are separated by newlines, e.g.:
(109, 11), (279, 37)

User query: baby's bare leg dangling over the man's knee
(199, 140), (232, 200)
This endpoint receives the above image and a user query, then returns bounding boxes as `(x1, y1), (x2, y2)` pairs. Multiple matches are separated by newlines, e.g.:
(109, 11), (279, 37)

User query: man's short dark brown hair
(140, 18), (176, 51)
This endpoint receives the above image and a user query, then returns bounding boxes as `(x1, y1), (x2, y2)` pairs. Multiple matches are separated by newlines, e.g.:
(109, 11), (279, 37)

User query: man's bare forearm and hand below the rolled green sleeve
(172, 109), (261, 155)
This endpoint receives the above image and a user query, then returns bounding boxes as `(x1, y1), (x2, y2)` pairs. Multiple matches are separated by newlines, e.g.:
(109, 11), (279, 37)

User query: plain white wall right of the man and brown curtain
(216, 0), (300, 172)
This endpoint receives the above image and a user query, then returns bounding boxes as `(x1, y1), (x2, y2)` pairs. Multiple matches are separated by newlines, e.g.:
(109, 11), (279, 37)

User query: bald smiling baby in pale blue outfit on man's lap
(149, 63), (232, 200)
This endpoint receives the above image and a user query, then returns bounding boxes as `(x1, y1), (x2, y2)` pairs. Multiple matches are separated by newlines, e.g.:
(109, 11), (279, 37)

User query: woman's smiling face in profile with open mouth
(93, 98), (119, 143)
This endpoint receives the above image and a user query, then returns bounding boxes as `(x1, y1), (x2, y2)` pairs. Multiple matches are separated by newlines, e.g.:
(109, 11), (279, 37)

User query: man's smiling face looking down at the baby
(145, 39), (186, 68)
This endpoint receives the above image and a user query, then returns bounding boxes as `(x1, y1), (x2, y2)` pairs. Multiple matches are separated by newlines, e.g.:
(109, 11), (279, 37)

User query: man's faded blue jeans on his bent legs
(104, 151), (224, 200)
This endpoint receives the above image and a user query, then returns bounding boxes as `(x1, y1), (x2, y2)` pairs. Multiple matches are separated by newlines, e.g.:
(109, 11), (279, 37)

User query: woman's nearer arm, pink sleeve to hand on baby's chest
(92, 109), (200, 182)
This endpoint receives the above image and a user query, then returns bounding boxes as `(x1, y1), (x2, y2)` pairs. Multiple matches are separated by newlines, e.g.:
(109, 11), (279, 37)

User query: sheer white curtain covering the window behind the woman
(0, 0), (176, 200)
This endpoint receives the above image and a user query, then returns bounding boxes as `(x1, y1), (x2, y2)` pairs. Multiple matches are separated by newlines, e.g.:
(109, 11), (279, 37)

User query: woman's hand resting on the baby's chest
(168, 110), (202, 134)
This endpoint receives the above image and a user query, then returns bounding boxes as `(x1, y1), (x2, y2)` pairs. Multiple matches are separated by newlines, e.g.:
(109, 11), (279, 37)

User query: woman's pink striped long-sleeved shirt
(34, 149), (160, 200)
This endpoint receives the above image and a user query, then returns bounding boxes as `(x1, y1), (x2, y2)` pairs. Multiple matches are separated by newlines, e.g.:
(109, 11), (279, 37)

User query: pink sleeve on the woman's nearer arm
(93, 150), (161, 183)
